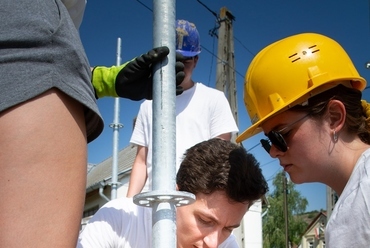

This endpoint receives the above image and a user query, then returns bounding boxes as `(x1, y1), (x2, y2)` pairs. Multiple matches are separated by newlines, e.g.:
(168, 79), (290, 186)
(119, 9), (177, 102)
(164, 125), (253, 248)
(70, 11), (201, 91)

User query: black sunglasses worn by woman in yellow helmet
(260, 113), (310, 154)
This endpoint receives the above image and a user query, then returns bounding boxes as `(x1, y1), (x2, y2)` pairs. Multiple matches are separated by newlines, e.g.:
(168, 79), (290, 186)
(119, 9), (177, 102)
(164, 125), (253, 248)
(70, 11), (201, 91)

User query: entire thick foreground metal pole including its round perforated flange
(134, 0), (195, 248)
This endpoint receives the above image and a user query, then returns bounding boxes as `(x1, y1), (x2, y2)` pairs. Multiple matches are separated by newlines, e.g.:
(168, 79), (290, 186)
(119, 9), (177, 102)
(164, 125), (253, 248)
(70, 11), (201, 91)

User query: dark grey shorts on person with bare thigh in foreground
(0, 0), (103, 142)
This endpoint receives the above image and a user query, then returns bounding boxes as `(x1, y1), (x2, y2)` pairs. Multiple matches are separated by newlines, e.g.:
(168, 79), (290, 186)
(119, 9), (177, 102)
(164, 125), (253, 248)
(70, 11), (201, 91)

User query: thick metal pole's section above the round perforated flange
(153, 0), (176, 193)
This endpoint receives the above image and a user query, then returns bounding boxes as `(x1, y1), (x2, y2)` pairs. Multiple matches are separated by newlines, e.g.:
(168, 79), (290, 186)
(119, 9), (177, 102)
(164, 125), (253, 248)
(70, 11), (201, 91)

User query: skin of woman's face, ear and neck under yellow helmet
(261, 100), (369, 194)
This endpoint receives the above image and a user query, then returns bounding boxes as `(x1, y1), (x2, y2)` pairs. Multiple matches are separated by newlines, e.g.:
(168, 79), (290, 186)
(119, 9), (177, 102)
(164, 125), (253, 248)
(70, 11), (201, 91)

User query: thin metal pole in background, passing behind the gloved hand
(109, 38), (123, 200)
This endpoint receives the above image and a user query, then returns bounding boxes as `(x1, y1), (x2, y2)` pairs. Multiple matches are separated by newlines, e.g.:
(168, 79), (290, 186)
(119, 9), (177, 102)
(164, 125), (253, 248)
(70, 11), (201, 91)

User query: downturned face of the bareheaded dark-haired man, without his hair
(176, 191), (249, 248)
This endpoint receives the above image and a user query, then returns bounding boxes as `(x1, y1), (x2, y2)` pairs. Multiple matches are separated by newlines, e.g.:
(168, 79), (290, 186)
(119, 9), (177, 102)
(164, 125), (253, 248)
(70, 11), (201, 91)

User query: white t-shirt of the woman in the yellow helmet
(325, 149), (370, 248)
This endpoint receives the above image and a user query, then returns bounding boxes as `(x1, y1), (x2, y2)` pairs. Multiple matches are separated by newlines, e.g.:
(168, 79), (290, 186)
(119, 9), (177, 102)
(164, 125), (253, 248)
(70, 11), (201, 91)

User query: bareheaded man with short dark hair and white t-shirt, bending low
(78, 138), (268, 248)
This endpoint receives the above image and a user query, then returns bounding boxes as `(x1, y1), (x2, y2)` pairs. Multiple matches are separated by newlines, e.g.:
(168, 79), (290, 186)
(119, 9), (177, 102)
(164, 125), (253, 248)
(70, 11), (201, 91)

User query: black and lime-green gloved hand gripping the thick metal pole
(91, 46), (185, 101)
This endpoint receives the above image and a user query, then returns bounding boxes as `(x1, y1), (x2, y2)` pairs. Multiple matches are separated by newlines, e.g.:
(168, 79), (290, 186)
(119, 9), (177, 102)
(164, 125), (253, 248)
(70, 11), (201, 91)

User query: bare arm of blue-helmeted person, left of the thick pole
(126, 146), (148, 197)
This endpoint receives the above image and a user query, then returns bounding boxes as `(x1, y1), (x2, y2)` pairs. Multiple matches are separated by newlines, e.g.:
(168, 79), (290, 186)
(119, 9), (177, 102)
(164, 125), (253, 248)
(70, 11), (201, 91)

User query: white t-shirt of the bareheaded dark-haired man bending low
(77, 197), (238, 248)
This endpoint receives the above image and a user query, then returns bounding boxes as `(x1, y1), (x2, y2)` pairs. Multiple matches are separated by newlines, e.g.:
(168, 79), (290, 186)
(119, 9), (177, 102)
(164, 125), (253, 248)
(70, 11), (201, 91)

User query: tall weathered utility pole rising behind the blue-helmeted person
(216, 7), (238, 142)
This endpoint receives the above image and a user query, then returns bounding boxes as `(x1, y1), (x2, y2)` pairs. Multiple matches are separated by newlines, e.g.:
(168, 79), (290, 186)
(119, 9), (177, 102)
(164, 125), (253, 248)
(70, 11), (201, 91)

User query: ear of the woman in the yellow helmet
(328, 100), (347, 132)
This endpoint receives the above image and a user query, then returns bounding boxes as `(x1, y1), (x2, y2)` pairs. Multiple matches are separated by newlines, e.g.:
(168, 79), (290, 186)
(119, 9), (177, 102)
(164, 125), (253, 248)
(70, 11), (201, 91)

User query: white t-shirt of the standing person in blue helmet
(130, 83), (238, 191)
